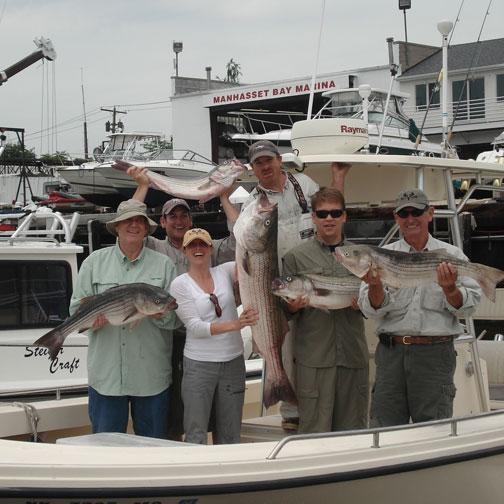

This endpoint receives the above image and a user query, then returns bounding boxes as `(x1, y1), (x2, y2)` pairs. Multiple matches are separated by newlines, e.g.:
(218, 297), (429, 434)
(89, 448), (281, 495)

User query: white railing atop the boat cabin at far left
(0, 208), (80, 245)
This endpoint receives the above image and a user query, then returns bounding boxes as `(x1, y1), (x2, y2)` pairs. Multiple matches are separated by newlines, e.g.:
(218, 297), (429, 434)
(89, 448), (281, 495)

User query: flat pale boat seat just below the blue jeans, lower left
(56, 432), (194, 447)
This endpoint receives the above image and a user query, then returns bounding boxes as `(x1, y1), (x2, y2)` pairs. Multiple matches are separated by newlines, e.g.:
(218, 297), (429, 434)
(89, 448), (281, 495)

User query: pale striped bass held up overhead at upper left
(112, 159), (247, 203)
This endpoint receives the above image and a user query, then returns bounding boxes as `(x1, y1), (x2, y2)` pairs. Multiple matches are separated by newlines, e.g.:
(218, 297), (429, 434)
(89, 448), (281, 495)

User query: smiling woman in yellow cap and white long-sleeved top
(170, 228), (258, 444)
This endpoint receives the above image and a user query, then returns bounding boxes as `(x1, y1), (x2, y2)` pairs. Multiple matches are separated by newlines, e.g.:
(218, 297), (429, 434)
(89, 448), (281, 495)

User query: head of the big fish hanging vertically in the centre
(233, 193), (278, 253)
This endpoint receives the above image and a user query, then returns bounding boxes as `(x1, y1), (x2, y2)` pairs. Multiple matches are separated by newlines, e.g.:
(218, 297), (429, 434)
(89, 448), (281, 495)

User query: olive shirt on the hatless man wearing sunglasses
(283, 238), (369, 368)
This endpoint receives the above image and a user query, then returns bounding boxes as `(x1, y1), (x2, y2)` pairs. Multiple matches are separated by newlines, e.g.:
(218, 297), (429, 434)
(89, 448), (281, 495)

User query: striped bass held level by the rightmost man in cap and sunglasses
(334, 245), (504, 302)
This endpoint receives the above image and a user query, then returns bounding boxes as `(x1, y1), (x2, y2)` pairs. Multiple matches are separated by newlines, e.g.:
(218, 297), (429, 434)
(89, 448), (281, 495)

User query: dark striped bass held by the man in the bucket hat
(33, 283), (177, 359)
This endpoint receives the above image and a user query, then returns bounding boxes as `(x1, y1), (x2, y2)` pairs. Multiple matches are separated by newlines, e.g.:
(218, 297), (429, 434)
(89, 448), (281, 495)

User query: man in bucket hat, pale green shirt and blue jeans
(70, 200), (178, 438)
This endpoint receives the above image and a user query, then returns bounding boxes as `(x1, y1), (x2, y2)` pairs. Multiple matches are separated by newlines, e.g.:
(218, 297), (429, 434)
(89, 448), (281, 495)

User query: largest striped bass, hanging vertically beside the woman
(233, 193), (296, 408)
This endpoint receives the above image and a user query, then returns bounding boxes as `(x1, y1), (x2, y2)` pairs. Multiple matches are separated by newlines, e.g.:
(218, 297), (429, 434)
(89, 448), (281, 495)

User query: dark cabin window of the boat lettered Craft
(0, 261), (72, 329)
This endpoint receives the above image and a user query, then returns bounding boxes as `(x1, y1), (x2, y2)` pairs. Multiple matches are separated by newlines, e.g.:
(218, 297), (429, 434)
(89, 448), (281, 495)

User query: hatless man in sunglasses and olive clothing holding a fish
(283, 187), (369, 433)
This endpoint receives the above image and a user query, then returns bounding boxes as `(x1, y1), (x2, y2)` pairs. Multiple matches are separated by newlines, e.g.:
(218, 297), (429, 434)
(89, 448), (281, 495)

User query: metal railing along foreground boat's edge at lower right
(266, 410), (504, 460)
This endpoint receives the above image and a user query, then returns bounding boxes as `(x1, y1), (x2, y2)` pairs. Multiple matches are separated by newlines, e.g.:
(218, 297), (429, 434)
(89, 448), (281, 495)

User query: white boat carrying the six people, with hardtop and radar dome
(0, 119), (504, 504)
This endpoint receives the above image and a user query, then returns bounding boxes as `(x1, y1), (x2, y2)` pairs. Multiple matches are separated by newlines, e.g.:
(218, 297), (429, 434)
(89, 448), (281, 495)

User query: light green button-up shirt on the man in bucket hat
(70, 244), (177, 396)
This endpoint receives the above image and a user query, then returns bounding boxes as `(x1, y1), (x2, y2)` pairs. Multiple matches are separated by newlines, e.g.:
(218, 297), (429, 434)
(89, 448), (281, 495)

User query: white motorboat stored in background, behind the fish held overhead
(59, 132), (215, 208)
